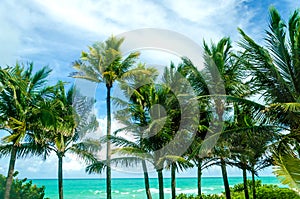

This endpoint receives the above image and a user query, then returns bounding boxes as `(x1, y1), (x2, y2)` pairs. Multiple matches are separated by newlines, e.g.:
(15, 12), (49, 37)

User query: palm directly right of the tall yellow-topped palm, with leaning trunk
(86, 64), (158, 199)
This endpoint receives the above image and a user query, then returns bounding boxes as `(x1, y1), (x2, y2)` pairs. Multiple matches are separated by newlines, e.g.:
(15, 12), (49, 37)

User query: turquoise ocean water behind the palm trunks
(32, 177), (280, 199)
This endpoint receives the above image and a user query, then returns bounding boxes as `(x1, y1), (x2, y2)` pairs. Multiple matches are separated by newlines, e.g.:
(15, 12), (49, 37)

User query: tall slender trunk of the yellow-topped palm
(106, 85), (111, 199)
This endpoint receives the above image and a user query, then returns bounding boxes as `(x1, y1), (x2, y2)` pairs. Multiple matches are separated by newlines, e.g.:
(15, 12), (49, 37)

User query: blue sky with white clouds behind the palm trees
(0, 0), (300, 178)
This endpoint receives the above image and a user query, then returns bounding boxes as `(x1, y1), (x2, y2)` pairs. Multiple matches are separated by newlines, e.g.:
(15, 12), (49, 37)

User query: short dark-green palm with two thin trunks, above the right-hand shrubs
(224, 105), (277, 198)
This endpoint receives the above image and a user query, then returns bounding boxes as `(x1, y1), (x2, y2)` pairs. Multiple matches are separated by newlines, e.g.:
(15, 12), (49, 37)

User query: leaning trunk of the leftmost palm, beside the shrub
(4, 145), (18, 199)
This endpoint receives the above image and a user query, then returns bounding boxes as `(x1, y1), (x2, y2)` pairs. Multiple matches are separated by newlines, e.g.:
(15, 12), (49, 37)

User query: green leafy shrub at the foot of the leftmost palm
(0, 173), (45, 199)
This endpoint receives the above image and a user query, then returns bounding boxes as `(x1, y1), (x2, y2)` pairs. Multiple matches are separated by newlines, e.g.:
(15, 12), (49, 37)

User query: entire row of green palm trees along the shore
(0, 7), (300, 199)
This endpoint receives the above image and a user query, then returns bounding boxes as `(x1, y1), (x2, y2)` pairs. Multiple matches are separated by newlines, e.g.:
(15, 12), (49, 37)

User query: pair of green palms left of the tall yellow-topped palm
(0, 63), (100, 199)
